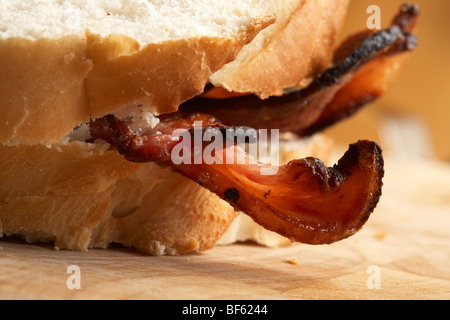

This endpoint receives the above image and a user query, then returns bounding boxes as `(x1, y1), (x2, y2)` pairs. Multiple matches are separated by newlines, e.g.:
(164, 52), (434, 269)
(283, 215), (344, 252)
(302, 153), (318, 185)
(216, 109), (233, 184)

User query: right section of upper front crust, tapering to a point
(86, 15), (276, 117)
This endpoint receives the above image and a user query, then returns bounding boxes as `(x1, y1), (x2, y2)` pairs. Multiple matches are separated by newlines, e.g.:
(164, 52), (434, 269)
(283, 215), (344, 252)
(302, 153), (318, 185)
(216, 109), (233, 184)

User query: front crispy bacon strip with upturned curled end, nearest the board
(90, 114), (384, 244)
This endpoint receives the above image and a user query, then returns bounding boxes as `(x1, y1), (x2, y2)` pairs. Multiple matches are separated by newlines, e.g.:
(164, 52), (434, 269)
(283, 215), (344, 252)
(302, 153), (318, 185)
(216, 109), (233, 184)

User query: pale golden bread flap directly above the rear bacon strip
(210, 0), (350, 98)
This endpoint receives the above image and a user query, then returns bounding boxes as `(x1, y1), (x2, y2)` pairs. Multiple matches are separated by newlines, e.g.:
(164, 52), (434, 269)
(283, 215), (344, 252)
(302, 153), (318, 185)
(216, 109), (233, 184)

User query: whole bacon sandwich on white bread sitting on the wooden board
(0, 0), (418, 255)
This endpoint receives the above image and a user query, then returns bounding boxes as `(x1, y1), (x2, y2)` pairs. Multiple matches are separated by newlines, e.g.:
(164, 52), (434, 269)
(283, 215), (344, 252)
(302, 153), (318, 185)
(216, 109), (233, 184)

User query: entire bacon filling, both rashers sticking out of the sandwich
(90, 5), (418, 244)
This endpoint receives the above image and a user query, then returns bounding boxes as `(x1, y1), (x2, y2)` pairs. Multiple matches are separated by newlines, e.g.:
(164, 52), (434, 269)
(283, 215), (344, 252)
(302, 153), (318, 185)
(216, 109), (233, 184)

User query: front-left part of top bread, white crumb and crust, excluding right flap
(0, 0), (276, 145)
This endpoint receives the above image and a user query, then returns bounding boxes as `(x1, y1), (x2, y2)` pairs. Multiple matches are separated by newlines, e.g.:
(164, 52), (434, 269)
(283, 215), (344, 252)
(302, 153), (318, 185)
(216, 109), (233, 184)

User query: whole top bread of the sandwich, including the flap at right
(0, 0), (349, 145)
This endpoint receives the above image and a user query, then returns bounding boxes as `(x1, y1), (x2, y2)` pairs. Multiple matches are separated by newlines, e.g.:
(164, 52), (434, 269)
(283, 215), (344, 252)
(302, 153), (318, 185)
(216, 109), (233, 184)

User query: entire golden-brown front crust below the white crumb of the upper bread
(0, 14), (276, 145)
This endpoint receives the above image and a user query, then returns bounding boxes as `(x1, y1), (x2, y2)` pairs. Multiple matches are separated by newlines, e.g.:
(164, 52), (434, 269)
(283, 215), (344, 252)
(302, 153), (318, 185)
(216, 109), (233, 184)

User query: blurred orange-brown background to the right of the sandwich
(326, 0), (450, 162)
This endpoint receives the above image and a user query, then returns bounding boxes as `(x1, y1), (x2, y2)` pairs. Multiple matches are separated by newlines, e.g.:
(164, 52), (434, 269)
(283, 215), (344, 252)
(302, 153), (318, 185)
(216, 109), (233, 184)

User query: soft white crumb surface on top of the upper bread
(0, 0), (268, 44)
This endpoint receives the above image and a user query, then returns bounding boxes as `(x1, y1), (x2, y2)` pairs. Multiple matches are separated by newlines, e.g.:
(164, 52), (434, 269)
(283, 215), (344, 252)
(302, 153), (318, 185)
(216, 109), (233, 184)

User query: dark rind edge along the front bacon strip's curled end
(230, 140), (384, 245)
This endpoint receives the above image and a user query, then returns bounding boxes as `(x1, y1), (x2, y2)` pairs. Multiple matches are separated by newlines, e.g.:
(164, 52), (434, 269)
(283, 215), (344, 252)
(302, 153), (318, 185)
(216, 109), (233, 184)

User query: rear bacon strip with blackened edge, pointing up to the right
(180, 5), (418, 135)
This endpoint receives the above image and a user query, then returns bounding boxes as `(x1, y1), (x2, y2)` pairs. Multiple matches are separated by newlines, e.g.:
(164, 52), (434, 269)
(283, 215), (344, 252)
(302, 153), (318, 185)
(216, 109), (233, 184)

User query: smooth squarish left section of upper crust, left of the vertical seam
(0, 36), (92, 144)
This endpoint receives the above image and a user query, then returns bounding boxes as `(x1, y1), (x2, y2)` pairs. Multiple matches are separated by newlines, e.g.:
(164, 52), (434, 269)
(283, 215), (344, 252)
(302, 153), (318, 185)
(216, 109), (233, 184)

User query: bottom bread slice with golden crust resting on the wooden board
(0, 136), (330, 255)
